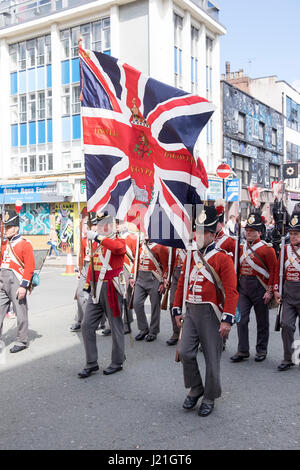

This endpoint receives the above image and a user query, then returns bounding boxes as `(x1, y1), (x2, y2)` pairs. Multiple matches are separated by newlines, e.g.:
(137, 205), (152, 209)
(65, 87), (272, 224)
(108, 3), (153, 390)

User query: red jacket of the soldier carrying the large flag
(84, 238), (126, 289)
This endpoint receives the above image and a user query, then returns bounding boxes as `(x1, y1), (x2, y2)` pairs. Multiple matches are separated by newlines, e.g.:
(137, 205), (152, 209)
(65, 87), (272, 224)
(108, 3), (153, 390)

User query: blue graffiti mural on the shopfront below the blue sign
(20, 203), (50, 235)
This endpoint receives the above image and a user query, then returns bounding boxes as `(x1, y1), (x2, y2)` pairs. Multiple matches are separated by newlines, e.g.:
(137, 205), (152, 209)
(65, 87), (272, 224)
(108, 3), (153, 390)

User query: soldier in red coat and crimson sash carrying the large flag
(78, 215), (126, 378)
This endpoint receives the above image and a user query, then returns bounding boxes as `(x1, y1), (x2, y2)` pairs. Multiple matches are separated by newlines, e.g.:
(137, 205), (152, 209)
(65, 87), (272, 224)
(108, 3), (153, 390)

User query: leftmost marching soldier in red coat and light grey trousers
(0, 210), (35, 353)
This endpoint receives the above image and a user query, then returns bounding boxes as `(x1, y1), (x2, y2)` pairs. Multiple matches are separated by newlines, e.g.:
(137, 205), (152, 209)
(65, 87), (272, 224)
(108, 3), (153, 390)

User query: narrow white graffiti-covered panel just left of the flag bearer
(55, 203), (74, 253)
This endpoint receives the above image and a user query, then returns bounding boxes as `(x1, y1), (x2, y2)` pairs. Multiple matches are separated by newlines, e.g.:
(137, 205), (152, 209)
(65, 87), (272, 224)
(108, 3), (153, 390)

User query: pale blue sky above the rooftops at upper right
(216, 0), (300, 91)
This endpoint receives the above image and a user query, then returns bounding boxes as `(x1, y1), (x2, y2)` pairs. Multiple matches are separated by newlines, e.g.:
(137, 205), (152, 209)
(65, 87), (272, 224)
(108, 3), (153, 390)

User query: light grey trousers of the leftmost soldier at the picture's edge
(0, 269), (28, 346)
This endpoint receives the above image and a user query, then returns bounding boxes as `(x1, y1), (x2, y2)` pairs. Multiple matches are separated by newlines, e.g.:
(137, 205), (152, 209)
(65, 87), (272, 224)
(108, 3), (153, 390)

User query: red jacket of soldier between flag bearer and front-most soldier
(131, 242), (169, 282)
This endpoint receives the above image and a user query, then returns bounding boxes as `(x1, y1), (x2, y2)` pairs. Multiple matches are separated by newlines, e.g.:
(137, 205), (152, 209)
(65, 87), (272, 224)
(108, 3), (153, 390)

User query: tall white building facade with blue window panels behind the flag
(0, 0), (226, 249)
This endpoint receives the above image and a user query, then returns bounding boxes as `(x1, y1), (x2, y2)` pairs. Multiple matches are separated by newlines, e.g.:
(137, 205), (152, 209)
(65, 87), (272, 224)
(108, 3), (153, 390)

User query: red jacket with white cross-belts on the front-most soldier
(173, 243), (238, 323)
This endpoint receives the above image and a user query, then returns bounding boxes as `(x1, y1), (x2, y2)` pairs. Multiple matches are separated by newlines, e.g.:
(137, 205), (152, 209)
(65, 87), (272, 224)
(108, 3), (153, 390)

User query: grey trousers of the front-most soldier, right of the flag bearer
(178, 303), (223, 400)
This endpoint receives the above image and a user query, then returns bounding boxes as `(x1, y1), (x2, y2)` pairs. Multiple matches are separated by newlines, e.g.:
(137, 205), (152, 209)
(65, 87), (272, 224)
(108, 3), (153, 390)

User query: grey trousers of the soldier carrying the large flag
(81, 282), (125, 368)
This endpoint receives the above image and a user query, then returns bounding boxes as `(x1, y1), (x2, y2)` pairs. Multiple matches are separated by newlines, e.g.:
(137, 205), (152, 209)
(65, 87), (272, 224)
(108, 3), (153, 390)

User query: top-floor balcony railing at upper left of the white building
(0, 0), (95, 28)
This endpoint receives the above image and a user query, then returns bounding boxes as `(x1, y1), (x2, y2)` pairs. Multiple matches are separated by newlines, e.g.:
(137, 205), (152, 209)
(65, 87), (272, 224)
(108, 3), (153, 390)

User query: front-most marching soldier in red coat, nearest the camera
(173, 206), (238, 416)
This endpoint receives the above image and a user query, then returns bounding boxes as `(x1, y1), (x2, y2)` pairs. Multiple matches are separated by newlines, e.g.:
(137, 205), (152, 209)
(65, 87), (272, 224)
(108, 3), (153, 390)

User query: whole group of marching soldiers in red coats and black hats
(0, 204), (300, 417)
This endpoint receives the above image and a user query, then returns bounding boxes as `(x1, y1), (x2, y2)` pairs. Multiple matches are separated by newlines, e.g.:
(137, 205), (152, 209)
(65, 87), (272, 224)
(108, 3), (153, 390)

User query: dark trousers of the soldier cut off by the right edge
(281, 281), (300, 363)
